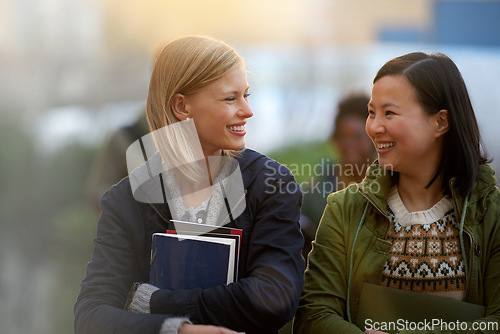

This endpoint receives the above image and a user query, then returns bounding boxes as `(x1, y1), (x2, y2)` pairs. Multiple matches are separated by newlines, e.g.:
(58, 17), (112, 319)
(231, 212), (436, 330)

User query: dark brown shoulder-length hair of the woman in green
(373, 52), (488, 196)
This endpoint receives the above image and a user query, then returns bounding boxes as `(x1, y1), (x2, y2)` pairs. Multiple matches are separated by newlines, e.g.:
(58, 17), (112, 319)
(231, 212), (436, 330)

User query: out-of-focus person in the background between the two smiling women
(300, 93), (376, 257)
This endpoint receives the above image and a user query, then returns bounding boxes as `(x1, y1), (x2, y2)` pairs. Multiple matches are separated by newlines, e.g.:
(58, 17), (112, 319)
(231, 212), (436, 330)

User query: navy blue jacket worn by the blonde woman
(74, 149), (304, 334)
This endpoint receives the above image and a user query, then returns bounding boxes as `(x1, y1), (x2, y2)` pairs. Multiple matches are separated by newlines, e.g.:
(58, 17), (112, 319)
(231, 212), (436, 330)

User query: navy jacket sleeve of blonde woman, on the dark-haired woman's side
(151, 162), (304, 334)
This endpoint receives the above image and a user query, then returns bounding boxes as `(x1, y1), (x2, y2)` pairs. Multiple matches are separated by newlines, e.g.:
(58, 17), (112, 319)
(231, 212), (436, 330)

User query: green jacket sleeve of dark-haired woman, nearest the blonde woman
(293, 195), (362, 334)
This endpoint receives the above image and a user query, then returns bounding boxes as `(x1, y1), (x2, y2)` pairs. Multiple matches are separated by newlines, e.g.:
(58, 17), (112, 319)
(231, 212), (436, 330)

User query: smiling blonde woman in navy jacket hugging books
(75, 36), (304, 334)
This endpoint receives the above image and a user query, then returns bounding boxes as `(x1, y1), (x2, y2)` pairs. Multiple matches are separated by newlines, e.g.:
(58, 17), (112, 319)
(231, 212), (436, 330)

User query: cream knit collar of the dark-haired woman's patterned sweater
(387, 186), (453, 226)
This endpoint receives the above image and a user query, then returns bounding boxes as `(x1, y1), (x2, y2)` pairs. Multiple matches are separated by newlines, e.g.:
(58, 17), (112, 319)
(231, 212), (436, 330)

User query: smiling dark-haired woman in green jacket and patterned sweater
(294, 53), (500, 333)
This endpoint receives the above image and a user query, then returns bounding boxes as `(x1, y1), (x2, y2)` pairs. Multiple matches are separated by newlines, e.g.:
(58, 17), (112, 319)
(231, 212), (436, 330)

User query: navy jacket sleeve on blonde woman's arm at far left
(74, 184), (167, 334)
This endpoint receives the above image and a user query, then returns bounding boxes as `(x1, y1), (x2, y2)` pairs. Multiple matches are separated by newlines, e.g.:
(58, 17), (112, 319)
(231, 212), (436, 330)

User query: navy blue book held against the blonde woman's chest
(150, 233), (237, 290)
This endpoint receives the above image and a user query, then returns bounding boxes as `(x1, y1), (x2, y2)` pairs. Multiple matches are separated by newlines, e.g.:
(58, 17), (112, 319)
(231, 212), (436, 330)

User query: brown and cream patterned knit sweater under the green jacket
(380, 187), (465, 300)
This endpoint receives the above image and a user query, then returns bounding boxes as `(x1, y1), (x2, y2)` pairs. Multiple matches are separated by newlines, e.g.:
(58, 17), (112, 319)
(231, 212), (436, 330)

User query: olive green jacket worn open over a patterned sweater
(294, 163), (500, 334)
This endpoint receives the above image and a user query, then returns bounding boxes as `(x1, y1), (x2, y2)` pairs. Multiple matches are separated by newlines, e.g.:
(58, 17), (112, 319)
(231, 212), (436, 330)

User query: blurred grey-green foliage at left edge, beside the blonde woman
(0, 115), (98, 334)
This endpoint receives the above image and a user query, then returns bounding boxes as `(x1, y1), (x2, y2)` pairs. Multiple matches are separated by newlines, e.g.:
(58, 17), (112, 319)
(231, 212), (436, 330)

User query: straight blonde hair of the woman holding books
(146, 36), (244, 180)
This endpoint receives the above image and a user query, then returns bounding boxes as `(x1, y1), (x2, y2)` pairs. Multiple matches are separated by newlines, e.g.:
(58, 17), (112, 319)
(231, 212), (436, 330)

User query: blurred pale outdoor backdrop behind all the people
(0, 0), (500, 334)
